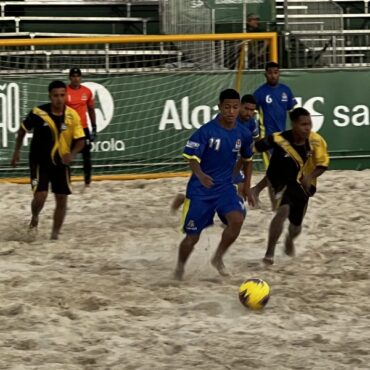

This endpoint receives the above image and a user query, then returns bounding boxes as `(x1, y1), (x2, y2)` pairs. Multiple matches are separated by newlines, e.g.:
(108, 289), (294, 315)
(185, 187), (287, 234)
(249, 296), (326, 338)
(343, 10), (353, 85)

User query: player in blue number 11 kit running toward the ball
(175, 89), (253, 280)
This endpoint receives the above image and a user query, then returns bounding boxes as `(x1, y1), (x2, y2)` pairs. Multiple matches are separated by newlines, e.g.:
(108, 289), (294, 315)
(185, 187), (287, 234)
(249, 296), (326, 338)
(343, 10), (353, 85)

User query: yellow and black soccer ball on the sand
(239, 279), (270, 310)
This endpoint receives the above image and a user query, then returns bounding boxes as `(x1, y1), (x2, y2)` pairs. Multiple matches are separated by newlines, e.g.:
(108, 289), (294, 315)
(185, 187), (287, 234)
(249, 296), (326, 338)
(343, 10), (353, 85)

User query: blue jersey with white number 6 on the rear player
(253, 83), (297, 137)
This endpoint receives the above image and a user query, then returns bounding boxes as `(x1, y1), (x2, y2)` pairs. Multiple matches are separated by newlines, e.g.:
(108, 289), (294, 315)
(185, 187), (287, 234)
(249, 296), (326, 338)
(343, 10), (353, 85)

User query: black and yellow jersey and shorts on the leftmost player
(22, 103), (84, 194)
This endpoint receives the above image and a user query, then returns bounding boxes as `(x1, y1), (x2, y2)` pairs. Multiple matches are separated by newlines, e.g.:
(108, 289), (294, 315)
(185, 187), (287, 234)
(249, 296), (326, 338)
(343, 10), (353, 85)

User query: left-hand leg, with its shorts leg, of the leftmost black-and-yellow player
(29, 162), (49, 229)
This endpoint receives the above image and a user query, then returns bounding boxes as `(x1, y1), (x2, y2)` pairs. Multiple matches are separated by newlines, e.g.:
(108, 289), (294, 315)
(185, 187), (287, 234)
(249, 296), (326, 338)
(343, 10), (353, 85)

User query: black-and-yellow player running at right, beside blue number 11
(255, 108), (329, 264)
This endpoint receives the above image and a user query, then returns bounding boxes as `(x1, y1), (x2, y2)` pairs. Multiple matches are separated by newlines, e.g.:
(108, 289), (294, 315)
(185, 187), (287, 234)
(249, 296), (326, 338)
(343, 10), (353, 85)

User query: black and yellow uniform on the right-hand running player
(255, 130), (329, 226)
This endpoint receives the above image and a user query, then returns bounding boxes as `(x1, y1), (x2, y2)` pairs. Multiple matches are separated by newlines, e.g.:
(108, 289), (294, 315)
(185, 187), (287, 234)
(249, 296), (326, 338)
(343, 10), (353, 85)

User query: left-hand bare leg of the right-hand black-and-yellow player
(263, 204), (290, 265)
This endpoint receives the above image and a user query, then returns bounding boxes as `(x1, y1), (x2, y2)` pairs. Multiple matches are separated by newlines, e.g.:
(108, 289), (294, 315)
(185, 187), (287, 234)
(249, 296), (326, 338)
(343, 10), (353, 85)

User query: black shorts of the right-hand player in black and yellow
(279, 183), (309, 226)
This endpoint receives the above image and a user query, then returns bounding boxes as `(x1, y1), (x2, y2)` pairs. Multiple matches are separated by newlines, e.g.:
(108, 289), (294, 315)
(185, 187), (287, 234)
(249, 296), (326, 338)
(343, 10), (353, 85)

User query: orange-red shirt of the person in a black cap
(66, 85), (94, 128)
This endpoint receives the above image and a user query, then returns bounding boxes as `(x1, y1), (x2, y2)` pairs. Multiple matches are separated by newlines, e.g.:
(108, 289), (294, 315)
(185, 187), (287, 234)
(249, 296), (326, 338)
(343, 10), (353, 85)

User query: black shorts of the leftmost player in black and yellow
(30, 162), (72, 195)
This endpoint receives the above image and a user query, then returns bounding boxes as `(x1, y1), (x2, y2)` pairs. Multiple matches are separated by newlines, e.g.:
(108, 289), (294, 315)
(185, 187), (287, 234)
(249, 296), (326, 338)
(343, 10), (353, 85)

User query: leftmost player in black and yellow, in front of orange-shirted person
(12, 81), (85, 239)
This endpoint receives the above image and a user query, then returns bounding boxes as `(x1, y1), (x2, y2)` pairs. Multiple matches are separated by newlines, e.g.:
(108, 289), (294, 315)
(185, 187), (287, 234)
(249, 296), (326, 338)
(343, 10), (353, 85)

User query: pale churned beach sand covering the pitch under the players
(0, 171), (370, 370)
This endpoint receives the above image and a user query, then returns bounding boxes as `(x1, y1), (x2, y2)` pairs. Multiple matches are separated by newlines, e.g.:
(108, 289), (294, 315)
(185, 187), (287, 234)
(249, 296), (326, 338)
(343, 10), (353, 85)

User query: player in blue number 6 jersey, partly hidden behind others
(252, 62), (297, 204)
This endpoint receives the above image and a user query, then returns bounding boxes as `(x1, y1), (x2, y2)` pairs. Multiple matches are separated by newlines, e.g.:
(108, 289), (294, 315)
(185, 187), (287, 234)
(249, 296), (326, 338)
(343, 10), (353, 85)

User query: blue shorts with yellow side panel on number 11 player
(182, 187), (246, 234)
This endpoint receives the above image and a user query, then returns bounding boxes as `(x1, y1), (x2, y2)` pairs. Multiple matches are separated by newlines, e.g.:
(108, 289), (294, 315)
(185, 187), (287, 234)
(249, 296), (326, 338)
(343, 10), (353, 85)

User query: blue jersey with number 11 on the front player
(183, 117), (253, 199)
